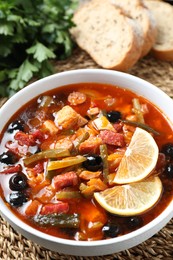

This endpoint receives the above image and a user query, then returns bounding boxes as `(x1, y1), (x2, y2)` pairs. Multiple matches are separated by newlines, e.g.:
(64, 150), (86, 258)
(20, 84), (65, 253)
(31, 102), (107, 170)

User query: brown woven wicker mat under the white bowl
(0, 49), (173, 260)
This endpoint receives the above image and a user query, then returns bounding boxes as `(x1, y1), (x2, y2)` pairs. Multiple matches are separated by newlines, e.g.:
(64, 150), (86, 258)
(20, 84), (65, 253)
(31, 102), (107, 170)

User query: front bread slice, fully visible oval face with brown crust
(71, 1), (142, 71)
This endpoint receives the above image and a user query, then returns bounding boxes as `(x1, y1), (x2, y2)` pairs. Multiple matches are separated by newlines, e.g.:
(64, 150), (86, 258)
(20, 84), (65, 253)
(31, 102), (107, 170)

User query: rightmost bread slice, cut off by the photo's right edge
(144, 0), (173, 61)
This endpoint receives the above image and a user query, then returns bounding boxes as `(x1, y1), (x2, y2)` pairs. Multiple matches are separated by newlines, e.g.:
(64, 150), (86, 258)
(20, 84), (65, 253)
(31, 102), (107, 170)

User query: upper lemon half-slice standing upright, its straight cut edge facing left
(113, 127), (159, 184)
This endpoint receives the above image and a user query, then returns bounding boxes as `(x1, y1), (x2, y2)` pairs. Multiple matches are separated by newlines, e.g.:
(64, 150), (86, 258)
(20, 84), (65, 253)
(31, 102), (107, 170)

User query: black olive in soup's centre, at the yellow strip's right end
(82, 154), (103, 172)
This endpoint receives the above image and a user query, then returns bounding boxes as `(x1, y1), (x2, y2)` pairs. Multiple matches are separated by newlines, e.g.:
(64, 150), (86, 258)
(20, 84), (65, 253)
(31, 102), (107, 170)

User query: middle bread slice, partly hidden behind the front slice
(108, 0), (157, 57)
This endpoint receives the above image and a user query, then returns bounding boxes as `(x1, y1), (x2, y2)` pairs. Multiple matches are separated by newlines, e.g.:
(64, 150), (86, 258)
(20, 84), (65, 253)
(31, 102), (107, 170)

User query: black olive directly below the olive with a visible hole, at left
(9, 191), (27, 207)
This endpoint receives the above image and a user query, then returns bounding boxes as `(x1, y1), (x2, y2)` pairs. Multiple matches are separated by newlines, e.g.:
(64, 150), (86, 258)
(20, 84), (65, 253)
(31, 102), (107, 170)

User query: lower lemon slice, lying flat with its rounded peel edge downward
(94, 177), (162, 216)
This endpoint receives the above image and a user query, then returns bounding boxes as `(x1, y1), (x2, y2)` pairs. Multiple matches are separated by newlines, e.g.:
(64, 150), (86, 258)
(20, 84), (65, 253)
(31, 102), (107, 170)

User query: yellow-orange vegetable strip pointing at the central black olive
(47, 155), (86, 171)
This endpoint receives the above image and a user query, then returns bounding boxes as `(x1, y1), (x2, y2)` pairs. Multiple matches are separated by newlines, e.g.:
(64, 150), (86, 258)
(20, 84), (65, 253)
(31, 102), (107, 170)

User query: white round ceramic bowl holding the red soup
(0, 69), (173, 256)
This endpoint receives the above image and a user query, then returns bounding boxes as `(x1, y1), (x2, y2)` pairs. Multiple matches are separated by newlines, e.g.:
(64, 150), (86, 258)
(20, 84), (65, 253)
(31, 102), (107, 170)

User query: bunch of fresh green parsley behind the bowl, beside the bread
(0, 0), (78, 97)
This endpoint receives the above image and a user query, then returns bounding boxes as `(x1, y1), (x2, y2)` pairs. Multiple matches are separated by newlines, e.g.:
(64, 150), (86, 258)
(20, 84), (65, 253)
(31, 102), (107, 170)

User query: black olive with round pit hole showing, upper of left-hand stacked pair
(9, 173), (28, 191)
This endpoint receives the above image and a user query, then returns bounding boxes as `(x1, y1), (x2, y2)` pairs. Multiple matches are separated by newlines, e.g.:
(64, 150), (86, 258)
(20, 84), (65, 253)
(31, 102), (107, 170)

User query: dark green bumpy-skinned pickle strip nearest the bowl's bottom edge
(34, 213), (80, 228)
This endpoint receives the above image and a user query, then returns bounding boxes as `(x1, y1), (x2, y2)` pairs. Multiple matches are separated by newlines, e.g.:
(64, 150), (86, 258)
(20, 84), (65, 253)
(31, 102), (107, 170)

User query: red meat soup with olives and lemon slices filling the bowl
(0, 83), (173, 241)
